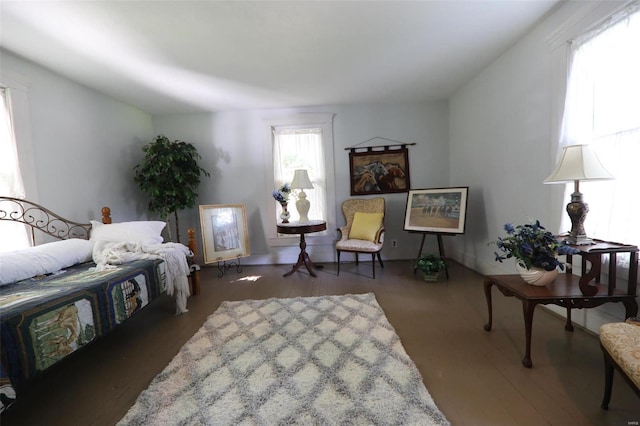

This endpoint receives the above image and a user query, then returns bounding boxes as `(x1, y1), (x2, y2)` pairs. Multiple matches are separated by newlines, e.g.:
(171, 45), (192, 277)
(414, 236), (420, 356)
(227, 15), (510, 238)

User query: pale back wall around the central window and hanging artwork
(154, 102), (449, 264)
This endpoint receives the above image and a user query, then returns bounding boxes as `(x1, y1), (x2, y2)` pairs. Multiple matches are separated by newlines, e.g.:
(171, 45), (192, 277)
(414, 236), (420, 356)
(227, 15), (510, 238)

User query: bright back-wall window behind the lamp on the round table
(268, 114), (335, 245)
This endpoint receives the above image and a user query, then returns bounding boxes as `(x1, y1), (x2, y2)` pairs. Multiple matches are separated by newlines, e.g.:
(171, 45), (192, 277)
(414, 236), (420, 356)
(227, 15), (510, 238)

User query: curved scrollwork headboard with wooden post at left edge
(0, 196), (111, 241)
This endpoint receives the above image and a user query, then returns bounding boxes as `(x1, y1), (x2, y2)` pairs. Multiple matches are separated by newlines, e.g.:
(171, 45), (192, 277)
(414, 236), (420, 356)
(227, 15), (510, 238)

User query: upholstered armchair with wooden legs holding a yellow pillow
(336, 197), (385, 278)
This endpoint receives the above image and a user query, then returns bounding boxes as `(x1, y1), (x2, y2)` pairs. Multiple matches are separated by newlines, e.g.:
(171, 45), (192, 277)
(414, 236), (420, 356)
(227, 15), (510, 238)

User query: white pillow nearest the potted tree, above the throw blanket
(89, 220), (165, 244)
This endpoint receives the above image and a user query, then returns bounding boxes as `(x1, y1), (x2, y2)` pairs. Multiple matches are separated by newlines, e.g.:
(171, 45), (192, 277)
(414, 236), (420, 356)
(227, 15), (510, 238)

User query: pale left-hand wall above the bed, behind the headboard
(0, 50), (153, 221)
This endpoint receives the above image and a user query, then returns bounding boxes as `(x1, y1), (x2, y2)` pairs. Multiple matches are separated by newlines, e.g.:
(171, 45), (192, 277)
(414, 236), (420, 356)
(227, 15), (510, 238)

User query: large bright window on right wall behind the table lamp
(561, 2), (640, 256)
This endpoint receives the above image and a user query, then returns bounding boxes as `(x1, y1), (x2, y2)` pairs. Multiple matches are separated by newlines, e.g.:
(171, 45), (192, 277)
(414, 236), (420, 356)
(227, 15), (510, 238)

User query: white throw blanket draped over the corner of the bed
(93, 241), (191, 314)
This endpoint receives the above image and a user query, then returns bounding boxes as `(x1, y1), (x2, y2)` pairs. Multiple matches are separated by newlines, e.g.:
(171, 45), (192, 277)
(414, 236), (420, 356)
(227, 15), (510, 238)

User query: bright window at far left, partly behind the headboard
(0, 86), (29, 252)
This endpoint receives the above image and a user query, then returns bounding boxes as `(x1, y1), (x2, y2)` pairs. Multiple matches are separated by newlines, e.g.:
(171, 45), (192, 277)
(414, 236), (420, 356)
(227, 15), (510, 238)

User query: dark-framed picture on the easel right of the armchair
(404, 186), (469, 234)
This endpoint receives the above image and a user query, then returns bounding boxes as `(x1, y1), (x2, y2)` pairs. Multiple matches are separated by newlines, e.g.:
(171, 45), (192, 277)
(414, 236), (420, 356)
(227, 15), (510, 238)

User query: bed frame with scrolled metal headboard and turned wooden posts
(0, 196), (200, 296)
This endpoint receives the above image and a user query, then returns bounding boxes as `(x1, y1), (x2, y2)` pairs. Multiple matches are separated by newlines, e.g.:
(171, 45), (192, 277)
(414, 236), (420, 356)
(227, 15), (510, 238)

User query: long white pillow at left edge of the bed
(0, 238), (93, 285)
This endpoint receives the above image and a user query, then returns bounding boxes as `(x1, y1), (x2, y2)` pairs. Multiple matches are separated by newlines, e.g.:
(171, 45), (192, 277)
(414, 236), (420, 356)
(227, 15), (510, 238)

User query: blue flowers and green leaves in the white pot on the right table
(490, 220), (580, 271)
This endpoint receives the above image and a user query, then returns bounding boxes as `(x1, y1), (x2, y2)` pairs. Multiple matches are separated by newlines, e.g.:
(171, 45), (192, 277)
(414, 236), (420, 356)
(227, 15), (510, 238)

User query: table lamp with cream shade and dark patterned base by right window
(544, 145), (614, 245)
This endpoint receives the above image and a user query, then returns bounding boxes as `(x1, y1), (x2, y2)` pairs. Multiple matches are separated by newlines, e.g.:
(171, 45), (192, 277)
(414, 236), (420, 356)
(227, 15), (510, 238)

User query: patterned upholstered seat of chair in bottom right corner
(600, 322), (640, 387)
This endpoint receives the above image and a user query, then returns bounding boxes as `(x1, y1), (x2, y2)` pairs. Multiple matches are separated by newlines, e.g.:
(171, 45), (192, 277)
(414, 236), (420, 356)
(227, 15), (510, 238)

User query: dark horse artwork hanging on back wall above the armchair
(349, 146), (411, 195)
